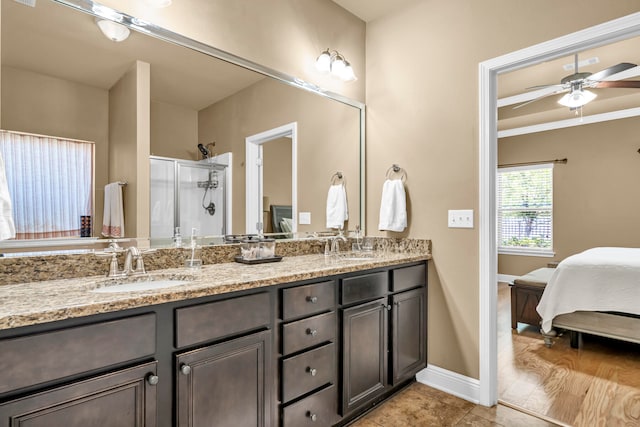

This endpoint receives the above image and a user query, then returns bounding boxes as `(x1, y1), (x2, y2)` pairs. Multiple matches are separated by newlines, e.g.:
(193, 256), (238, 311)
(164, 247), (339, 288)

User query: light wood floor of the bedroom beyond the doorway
(498, 283), (640, 427)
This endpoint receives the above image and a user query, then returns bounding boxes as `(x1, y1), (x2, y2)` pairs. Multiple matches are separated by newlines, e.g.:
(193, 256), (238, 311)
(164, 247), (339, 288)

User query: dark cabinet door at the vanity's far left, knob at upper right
(0, 362), (158, 427)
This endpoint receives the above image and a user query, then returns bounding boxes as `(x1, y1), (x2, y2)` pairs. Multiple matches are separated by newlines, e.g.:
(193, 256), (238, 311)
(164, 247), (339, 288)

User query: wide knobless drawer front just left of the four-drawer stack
(176, 292), (271, 348)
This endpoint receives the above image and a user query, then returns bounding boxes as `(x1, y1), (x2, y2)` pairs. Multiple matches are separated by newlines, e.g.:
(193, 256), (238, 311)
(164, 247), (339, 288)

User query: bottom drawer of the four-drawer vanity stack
(282, 385), (338, 427)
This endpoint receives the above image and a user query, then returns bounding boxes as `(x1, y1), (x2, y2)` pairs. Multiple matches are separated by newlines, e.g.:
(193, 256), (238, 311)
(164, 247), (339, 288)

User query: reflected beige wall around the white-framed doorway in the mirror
(198, 79), (360, 234)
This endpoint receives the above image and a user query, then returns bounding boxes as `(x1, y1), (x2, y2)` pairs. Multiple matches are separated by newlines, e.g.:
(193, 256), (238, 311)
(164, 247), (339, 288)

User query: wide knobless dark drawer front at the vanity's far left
(0, 313), (156, 393)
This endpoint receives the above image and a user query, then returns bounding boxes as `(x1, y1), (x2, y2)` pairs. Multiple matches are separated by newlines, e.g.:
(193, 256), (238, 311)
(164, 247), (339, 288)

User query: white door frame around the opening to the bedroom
(478, 13), (640, 406)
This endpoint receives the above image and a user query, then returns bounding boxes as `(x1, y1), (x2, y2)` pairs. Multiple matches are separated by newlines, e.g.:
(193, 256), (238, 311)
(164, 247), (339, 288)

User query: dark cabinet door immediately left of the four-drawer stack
(176, 331), (272, 427)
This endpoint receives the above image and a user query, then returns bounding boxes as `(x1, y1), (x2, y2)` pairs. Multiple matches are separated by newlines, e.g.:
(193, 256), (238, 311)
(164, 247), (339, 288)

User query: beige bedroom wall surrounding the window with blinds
(498, 118), (640, 275)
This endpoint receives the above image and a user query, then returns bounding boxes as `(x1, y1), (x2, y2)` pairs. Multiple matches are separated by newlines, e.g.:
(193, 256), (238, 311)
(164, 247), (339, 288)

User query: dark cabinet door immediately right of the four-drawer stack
(341, 298), (388, 415)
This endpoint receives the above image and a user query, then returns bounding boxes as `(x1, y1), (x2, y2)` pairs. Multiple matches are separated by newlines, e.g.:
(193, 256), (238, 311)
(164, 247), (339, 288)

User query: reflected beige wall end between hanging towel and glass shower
(109, 61), (150, 239)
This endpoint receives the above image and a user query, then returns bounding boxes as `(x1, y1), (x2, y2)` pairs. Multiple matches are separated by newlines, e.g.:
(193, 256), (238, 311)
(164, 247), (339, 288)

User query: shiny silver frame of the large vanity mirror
(0, 0), (366, 249)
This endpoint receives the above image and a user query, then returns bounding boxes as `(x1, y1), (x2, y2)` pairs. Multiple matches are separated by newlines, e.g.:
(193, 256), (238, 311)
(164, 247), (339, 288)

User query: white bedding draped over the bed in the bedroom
(536, 248), (640, 333)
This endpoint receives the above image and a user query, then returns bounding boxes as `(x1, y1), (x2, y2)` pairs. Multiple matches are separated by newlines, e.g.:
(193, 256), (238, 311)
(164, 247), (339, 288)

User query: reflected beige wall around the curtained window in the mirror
(0, 67), (109, 236)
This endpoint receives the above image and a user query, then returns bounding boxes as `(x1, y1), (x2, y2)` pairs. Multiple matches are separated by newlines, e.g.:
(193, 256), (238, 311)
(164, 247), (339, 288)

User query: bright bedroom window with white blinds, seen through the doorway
(497, 163), (553, 256)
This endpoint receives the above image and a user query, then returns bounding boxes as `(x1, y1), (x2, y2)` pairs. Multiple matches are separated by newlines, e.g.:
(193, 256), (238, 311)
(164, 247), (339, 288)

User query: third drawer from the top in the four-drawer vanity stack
(282, 343), (336, 402)
